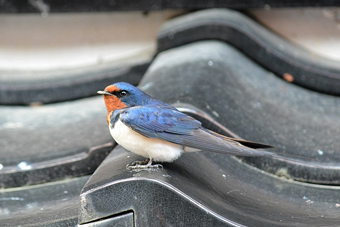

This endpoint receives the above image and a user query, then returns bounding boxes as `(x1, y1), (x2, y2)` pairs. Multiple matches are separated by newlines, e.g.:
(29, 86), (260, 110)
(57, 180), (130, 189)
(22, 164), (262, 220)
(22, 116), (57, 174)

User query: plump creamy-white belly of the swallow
(110, 120), (183, 162)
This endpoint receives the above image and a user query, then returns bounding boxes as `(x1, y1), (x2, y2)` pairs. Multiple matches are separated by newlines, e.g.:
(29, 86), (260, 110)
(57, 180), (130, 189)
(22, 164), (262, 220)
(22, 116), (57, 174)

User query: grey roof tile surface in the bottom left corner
(0, 176), (89, 227)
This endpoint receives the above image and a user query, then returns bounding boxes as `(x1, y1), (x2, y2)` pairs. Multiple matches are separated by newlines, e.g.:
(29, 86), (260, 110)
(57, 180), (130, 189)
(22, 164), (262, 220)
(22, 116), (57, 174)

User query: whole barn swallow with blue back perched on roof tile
(97, 82), (274, 168)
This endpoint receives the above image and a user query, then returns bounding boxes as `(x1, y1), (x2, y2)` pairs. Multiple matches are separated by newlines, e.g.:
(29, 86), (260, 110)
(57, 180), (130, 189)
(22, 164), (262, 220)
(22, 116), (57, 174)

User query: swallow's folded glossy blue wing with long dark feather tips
(116, 106), (273, 156)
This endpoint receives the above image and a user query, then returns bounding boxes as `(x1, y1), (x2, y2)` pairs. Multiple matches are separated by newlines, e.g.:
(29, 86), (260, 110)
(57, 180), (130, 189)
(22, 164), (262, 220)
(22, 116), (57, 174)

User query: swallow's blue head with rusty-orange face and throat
(97, 82), (150, 112)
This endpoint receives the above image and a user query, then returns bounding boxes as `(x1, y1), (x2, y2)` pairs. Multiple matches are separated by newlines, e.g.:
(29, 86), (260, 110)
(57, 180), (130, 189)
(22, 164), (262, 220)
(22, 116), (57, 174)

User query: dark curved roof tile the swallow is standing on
(79, 146), (340, 227)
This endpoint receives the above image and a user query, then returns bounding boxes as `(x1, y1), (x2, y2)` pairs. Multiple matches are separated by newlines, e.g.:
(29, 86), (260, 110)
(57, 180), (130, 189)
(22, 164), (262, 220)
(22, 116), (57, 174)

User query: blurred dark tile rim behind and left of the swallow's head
(0, 62), (149, 105)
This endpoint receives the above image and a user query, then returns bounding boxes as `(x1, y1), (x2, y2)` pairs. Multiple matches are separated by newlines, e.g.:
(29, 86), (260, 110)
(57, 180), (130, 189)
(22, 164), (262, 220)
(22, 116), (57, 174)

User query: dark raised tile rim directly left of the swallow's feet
(0, 143), (113, 188)
